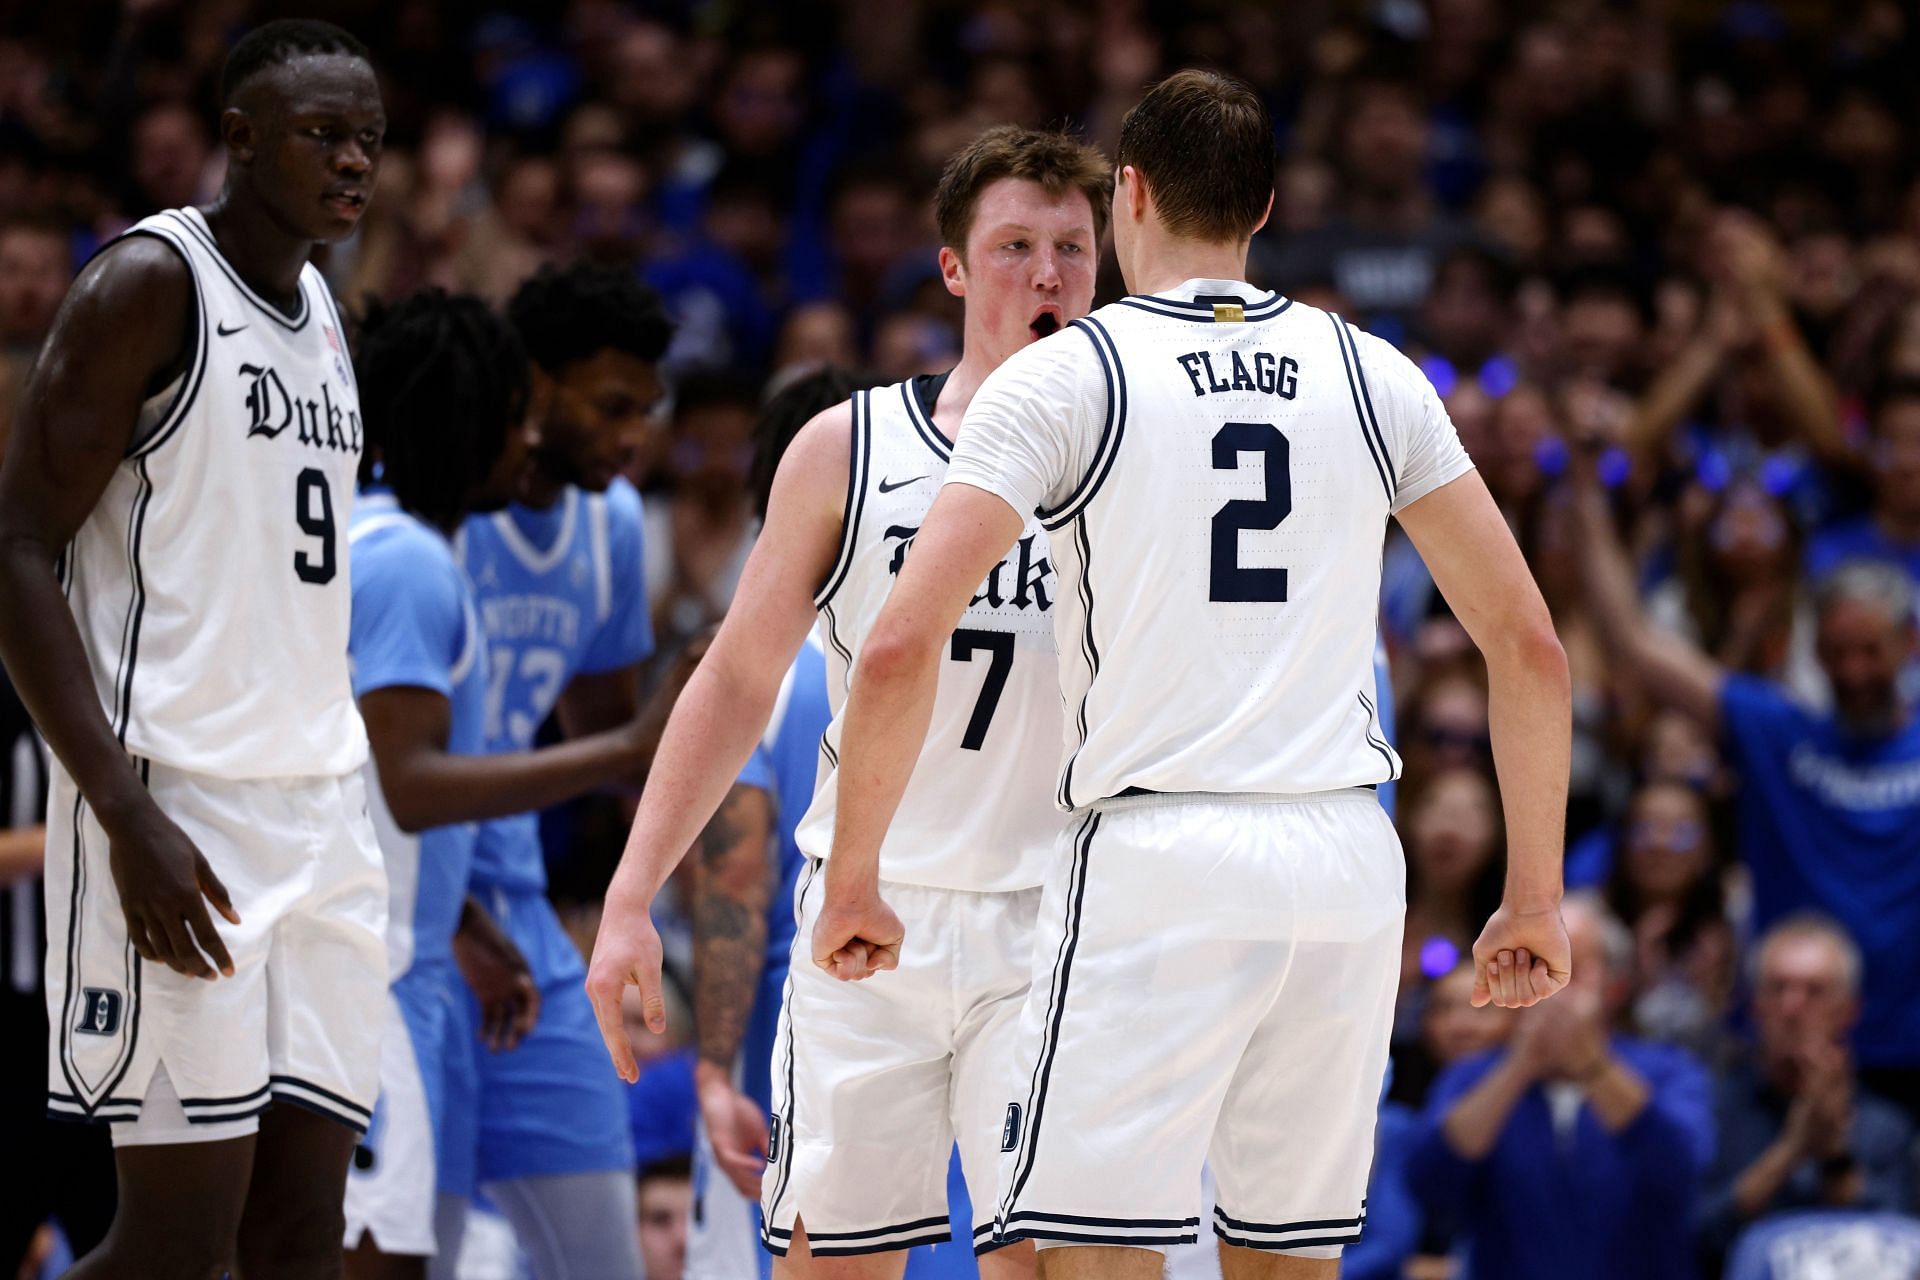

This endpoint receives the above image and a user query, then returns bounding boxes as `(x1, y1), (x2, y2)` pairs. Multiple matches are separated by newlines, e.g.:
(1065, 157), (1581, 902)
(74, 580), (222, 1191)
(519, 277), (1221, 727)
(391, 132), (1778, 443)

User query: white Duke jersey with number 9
(61, 209), (367, 779)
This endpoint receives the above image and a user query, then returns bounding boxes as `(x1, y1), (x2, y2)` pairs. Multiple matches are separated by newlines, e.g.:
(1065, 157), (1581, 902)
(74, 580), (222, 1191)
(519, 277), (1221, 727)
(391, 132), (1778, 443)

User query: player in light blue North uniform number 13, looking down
(434, 265), (672, 1280)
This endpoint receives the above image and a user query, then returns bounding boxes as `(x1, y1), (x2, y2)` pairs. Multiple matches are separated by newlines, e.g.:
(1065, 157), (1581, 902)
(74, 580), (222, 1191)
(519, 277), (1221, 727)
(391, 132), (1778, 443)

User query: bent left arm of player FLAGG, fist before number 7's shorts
(814, 484), (1025, 979)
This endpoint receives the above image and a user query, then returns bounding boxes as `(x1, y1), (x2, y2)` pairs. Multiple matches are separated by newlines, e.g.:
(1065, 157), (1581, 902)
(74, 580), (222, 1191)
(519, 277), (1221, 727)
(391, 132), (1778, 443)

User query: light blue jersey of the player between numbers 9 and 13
(348, 489), (488, 979)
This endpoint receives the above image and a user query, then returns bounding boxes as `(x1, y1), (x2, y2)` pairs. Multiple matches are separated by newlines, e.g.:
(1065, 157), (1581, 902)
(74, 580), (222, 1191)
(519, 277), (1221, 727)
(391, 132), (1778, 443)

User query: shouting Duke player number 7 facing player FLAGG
(589, 127), (1108, 1276)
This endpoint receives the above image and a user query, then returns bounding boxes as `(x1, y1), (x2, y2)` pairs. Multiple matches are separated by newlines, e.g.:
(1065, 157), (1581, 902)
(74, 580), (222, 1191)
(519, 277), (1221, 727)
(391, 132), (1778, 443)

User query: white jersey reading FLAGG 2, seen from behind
(947, 280), (1473, 808)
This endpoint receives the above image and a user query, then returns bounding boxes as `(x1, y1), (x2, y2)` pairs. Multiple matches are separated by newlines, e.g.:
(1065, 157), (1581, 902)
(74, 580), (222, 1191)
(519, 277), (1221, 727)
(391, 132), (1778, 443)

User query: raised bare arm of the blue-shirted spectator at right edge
(1572, 443), (1726, 729)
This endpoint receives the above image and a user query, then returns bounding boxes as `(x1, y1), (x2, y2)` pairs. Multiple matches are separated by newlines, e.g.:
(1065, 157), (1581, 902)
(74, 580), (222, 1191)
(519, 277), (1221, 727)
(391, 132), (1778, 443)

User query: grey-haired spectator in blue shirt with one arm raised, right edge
(1574, 447), (1920, 1113)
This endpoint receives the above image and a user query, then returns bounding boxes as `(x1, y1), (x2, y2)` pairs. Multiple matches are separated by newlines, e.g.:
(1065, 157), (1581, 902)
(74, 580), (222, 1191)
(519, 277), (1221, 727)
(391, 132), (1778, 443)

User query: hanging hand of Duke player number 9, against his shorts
(108, 802), (240, 979)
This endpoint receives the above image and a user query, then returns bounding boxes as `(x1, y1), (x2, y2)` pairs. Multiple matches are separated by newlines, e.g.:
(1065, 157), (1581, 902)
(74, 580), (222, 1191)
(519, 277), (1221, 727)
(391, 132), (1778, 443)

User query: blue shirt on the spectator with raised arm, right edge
(1720, 676), (1920, 1067)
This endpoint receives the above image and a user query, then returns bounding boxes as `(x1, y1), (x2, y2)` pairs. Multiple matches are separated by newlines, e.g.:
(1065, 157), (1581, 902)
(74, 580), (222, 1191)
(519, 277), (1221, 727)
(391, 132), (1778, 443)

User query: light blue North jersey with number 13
(455, 480), (653, 890)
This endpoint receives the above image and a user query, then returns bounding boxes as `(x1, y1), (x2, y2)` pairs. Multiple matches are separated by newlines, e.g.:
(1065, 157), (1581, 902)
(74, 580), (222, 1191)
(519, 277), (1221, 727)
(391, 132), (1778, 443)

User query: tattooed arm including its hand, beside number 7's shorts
(693, 783), (778, 1199)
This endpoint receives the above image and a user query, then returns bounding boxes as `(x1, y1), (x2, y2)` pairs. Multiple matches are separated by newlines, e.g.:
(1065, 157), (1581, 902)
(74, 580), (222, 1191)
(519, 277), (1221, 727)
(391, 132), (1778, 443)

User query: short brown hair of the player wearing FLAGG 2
(1117, 69), (1279, 242)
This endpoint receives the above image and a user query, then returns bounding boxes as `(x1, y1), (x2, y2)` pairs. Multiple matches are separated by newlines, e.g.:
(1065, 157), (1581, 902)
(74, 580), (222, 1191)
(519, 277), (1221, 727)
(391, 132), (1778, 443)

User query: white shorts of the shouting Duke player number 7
(760, 862), (1041, 1257)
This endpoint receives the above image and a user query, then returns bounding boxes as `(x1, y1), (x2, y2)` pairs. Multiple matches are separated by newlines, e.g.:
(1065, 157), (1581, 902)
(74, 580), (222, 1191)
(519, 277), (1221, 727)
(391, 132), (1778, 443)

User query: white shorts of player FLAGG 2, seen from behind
(996, 791), (1405, 1257)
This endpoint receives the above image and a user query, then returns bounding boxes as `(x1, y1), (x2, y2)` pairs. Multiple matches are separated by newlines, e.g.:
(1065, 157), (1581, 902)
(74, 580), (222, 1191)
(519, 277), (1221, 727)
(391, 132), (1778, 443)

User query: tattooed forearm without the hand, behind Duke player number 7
(693, 787), (776, 1067)
